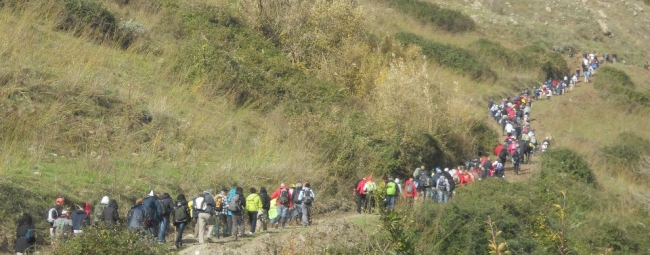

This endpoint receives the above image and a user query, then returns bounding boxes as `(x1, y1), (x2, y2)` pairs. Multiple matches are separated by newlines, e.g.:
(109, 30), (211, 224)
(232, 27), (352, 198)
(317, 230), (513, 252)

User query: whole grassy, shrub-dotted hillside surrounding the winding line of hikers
(0, 0), (650, 254)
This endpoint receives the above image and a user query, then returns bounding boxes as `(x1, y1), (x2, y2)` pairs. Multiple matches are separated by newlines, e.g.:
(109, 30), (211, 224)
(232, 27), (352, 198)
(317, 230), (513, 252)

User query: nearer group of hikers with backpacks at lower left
(15, 182), (316, 254)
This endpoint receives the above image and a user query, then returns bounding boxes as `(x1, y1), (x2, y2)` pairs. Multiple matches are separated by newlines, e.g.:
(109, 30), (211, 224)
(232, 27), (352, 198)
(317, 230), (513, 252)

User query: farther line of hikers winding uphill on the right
(353, 50), (604, 213)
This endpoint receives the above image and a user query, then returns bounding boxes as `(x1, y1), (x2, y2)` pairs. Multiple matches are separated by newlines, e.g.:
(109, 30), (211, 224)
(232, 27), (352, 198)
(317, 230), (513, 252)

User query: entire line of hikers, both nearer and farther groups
(15, 53), (616, 254)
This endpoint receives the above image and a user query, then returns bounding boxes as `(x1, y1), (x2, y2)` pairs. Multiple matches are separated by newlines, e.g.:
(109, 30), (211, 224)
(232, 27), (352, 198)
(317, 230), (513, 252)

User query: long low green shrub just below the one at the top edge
(395, 33), (497, 81)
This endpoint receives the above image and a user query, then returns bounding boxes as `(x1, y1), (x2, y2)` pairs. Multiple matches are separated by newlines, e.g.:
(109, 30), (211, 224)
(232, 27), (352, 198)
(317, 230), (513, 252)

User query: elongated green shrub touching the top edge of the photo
(388, 0), (476, 33)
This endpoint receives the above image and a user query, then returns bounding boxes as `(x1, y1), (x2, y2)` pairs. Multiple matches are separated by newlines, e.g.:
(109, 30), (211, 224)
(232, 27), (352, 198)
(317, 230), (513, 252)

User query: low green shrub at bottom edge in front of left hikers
(52, 227), (166, 255)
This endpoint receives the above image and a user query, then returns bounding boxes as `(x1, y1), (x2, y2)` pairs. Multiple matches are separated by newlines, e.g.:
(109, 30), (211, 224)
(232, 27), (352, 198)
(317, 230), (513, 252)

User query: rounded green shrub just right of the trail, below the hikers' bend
(541, 148), (596, 185)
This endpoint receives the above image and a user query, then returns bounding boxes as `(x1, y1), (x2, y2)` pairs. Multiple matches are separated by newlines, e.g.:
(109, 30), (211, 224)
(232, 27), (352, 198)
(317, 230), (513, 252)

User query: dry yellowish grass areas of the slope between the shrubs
(0, 1), (650, 252)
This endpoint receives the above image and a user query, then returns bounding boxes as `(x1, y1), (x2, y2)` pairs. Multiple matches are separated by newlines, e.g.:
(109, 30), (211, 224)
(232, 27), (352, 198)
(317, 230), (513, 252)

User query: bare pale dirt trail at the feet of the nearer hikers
(179, 213), (370, 255)
